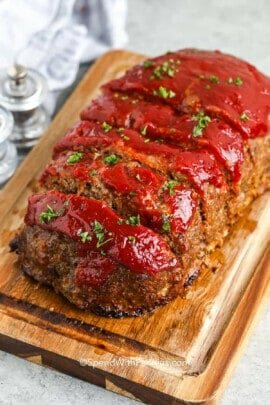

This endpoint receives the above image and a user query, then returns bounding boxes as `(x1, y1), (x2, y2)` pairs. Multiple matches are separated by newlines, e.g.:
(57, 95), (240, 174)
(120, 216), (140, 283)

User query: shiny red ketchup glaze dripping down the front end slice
(25, 191), (178, 282)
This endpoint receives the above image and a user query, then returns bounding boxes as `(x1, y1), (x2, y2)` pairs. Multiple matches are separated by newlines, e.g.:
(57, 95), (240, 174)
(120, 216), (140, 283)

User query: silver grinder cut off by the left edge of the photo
(0, 106), (18, 184)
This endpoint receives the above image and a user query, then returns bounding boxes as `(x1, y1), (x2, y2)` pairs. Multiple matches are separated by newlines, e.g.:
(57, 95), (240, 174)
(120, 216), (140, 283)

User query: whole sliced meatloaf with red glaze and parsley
(10, 49), (270, 317)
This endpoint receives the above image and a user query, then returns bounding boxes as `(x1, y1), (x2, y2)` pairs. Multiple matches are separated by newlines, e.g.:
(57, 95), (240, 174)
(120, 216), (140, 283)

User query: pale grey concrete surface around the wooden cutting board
(0, 0), (270, 405)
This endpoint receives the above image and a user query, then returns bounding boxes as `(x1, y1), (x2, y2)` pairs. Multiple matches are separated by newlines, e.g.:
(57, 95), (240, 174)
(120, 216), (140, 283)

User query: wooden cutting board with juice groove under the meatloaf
(0, 51), (270, 404)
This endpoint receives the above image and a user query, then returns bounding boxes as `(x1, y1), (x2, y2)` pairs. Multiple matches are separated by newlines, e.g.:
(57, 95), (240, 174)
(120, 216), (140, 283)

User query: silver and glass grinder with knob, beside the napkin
(0, 64), (49, 150)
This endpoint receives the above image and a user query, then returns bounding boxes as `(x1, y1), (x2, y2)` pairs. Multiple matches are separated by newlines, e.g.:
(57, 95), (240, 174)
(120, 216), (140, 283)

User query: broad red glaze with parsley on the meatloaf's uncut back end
(104, 50), (270, 137)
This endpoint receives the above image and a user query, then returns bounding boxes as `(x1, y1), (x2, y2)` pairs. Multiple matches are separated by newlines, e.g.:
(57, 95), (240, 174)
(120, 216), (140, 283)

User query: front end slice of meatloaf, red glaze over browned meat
(13, 191), (181, 317)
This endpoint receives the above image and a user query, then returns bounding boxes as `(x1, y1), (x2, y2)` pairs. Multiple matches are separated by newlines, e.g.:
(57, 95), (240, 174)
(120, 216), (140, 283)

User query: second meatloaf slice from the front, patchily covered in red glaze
(40, 151), (204, 267)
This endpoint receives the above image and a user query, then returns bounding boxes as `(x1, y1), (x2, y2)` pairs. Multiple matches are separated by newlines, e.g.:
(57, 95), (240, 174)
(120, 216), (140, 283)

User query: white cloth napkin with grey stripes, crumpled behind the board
(0, 0), (127, 111)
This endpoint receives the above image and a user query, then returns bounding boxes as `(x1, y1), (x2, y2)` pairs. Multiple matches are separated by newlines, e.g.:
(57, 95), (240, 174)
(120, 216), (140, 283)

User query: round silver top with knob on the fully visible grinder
(0, 64), (47, 112)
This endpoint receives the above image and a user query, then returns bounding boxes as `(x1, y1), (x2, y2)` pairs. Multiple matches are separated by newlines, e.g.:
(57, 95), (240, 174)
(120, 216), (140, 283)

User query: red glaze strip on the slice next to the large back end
(82, 91), (244, 182)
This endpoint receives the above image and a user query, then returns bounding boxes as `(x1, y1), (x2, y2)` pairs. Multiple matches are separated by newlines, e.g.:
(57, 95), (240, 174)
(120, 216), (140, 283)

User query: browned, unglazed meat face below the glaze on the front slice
(14, 226), (184, 317)
